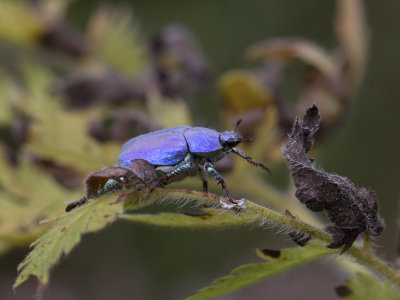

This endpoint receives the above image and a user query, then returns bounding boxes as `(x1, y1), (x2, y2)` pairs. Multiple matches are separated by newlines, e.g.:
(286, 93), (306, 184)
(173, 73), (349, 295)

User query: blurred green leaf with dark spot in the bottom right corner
(336, 272), (400, 300)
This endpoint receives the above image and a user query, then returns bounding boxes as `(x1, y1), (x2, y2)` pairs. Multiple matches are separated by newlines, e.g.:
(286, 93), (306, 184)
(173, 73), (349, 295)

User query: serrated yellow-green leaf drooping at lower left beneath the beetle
(14, 189), (249, 288)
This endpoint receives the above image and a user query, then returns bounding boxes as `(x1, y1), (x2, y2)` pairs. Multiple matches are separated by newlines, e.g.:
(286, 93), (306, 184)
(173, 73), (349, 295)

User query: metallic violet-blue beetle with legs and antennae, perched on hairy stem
(118, 120), (270, 205)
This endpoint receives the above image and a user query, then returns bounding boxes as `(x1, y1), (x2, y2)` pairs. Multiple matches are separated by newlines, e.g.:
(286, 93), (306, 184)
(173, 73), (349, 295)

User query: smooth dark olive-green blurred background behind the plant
(0, 0), (400, 299)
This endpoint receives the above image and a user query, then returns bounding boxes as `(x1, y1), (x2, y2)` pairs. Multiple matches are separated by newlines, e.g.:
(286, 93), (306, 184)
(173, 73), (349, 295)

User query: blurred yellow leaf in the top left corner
(0, 0), (44, 45)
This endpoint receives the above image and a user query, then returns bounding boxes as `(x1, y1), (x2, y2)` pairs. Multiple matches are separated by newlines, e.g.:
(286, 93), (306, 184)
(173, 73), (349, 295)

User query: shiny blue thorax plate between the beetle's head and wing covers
(184, 127), (222, 156)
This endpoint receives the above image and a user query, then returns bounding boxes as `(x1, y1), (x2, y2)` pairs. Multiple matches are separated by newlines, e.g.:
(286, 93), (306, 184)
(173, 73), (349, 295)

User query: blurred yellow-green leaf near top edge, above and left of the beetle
(87, 6), (148, 77)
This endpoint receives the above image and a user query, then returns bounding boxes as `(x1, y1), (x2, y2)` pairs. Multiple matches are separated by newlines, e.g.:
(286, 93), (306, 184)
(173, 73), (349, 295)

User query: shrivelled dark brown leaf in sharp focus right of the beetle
(282, 105), (384, 253)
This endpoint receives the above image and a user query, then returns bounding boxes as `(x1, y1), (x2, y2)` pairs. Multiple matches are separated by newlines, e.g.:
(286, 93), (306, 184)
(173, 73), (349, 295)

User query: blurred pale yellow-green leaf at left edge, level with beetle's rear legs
(0, 149), (78, 245)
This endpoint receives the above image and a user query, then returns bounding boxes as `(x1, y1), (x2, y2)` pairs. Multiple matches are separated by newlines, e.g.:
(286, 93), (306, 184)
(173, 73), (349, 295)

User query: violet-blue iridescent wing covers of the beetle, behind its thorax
(118, 126), (190, 167)
